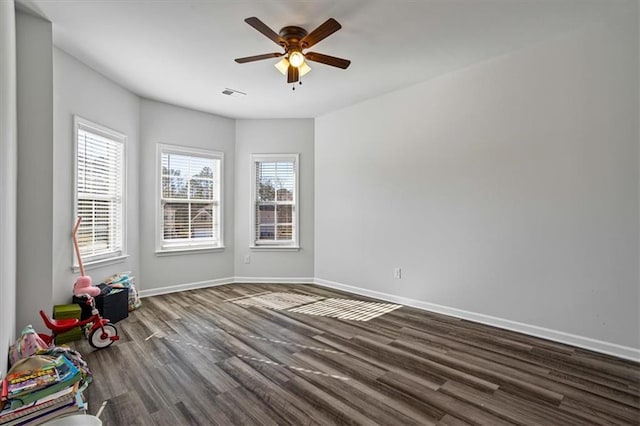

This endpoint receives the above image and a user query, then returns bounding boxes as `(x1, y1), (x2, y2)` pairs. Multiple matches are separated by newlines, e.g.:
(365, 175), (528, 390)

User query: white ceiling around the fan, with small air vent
(18, 0), (611, 118)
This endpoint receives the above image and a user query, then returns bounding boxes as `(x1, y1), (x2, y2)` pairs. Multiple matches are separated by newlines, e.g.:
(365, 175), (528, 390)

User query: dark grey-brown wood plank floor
(71, 284), (640, 426)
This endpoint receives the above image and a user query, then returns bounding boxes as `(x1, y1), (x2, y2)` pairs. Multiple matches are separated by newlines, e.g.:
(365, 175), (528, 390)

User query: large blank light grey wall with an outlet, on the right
(315, 8), (640, 358)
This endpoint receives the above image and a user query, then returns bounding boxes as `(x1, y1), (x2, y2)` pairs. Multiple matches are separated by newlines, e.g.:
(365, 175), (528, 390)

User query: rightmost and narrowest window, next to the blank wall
(252, 154), (298, 248)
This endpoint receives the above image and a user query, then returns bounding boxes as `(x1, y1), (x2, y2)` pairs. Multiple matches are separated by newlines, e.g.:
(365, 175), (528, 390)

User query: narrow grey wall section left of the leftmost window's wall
(16, 12), (53, 331)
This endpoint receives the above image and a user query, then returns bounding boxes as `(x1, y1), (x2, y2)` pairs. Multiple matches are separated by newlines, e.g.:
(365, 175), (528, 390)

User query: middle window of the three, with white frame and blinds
(158, 145), (223, 252)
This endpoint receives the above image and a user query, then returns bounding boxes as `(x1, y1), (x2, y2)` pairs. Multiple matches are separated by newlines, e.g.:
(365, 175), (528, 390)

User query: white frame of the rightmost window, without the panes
(249, 153), (300, 250)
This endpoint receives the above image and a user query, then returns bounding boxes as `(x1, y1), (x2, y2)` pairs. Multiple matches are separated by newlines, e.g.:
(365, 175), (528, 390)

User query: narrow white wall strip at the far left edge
(0, 0), (18, 377)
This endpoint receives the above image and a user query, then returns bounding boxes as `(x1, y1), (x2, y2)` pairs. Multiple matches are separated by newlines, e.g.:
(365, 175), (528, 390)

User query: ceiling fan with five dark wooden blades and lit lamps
(236, 17), (351, 83)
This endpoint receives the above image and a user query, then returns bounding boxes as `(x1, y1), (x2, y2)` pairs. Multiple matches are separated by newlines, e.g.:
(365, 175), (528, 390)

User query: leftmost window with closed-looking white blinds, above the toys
(74, 117), (126, 266)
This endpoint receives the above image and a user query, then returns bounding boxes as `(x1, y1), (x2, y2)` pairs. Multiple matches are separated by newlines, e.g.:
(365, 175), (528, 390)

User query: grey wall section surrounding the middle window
(140, 99), (235, 295)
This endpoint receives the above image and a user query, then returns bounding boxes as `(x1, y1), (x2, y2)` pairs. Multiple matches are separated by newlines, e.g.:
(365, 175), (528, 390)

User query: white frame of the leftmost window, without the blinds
(71, 115), (129, 272)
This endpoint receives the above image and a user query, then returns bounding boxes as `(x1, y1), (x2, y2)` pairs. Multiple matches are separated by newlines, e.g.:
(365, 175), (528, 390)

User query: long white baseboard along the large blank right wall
(314, 278), (640, 362)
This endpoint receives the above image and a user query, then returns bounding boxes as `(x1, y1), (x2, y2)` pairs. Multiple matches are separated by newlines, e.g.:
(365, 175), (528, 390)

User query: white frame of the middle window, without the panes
(155, 143), (225, 256)
